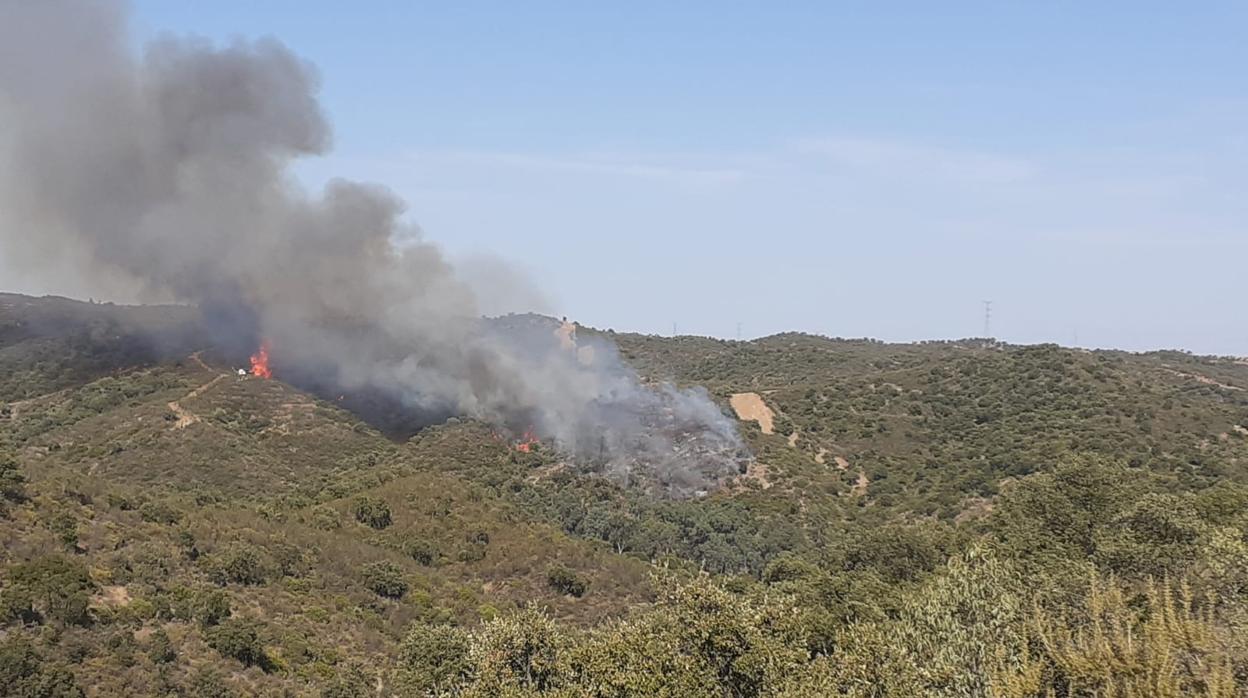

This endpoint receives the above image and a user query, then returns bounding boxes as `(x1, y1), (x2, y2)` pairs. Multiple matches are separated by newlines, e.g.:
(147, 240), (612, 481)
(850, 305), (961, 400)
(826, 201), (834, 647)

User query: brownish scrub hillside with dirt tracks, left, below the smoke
(0, 296), (651, 696)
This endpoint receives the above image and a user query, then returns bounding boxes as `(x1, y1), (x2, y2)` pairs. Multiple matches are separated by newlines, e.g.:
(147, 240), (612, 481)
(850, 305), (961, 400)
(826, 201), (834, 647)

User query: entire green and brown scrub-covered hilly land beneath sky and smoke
(0, 295), (1248, 697)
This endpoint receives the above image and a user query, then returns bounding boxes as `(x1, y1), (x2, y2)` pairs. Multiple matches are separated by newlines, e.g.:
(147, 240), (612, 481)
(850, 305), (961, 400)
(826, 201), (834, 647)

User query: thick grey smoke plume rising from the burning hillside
(0, 0), (740, 492)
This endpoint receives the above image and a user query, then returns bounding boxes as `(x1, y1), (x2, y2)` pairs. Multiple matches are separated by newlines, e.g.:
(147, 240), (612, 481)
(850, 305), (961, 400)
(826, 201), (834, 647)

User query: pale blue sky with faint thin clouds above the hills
(134, 0), (1248, 355)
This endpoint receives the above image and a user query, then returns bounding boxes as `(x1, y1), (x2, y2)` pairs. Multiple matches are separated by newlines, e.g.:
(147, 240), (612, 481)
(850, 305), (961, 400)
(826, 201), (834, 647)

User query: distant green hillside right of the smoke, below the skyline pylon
(617, 335), (1248, 518)
